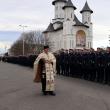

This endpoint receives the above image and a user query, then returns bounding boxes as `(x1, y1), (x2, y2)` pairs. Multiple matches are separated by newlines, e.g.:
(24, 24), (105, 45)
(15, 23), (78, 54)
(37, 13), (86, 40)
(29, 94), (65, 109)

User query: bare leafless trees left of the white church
(10, 31), (44, 55)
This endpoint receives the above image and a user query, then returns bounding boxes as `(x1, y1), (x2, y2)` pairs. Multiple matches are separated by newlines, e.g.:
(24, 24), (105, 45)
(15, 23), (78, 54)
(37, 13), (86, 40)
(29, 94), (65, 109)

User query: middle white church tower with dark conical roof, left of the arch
(63, 0), (76, 49)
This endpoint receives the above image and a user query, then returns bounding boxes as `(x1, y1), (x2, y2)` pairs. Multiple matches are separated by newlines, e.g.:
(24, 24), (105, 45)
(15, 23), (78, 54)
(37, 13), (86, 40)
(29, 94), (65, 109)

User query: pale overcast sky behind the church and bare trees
(0, 0), (110, 52)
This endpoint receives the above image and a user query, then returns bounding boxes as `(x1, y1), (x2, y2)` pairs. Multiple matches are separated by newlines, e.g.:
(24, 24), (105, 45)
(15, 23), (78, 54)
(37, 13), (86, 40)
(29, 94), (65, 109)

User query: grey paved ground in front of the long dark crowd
(0, 63), (110, 110)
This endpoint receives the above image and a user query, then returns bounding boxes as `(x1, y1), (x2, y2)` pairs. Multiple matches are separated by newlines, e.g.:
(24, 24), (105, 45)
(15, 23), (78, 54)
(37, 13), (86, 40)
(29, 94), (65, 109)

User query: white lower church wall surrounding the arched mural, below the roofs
(44, 26), (93, 52)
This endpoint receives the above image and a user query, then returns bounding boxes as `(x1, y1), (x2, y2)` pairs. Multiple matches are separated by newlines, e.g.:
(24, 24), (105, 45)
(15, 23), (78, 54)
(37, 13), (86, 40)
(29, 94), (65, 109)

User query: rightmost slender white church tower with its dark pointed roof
(80, 1), (93, 48)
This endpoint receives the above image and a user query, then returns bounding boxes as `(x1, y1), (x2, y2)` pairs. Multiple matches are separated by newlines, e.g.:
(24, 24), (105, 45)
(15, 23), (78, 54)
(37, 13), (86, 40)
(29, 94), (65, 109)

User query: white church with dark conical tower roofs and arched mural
(43, 0), (93, 52)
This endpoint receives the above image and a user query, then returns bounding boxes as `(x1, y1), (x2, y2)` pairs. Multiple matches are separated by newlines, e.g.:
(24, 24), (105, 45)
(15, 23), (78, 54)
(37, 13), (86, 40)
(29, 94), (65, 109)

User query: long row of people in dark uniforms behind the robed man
(1, 51), (110, 84)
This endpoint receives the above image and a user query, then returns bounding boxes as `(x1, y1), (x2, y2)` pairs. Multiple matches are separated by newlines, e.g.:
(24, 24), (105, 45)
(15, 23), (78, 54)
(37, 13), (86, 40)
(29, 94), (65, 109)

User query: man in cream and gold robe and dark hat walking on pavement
(34, 46), (56, 96)
